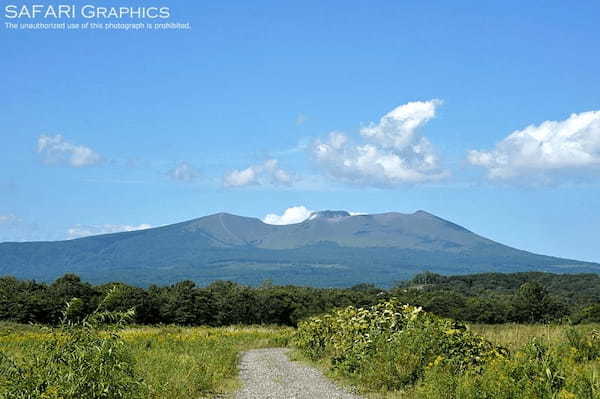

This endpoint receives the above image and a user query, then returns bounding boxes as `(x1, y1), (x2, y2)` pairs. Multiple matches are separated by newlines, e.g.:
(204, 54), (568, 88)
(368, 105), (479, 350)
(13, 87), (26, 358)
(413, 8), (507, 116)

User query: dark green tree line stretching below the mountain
(0, 272), (600, 326)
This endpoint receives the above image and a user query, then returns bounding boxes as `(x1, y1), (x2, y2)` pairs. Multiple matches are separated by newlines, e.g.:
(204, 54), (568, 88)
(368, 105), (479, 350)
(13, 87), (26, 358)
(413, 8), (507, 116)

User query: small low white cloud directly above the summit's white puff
(223, 159), (294, 187)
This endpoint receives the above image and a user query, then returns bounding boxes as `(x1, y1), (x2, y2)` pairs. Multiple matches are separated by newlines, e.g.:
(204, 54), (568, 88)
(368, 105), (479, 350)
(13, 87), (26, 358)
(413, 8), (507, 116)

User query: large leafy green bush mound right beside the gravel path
(295, 300), (507, 390)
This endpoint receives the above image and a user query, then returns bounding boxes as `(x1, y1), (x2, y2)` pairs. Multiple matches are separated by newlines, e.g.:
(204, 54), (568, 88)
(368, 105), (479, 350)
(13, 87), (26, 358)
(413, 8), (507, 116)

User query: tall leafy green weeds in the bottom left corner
(0, 289), (147, 399)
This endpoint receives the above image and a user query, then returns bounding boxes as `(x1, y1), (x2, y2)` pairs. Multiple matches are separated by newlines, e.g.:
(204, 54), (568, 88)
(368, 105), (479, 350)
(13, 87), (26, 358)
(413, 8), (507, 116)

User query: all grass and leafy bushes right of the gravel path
(294, 300), (600, 399)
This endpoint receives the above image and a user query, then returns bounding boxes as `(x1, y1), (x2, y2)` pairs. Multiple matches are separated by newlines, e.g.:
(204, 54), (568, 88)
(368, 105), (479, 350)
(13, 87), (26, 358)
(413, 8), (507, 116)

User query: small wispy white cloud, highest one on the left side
(37, 134), (102, 168)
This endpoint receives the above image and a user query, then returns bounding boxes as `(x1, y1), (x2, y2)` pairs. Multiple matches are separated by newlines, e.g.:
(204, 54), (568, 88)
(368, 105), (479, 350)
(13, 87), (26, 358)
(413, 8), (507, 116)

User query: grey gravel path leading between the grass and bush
(235, 348), (360, 399)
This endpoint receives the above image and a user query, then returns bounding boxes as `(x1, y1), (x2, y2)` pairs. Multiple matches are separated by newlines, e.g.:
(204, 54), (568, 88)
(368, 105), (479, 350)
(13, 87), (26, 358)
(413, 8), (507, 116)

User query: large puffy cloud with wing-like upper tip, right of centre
(312, 99), (447, 186)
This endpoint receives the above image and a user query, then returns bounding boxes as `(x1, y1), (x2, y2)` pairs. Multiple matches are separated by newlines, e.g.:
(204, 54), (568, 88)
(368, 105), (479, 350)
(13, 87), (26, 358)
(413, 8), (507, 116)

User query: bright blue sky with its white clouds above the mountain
(0, 0), (600, 262)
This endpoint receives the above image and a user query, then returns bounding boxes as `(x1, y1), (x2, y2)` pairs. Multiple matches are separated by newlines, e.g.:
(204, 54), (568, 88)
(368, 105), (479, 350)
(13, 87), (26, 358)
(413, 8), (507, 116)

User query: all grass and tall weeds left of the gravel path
(0, 287), (292, 399)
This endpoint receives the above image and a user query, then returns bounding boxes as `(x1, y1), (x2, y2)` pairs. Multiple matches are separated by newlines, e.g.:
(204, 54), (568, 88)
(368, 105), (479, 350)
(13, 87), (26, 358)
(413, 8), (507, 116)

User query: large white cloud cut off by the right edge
(468, 111), (600, 179)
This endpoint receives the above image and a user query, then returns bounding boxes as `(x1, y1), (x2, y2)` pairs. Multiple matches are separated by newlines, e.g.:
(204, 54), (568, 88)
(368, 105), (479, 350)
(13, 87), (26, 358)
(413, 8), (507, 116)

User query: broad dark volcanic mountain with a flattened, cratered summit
(0, 211), (600, 287)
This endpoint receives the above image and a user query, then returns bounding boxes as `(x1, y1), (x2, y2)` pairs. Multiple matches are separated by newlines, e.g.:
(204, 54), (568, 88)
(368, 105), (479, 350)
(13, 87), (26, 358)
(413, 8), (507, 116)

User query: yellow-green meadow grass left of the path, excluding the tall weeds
(0, 323), (293, 399)
